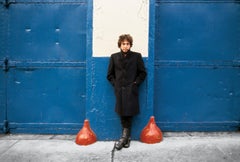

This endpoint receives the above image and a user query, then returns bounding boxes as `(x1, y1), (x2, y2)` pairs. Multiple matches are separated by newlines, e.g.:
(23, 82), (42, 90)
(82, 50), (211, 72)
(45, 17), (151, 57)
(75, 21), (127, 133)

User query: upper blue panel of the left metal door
(8, 3), (87, 61)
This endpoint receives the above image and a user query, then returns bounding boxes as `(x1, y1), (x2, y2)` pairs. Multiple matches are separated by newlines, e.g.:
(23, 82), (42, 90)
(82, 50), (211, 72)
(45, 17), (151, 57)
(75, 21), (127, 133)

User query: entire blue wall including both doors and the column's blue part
(0, 0), (240, 140)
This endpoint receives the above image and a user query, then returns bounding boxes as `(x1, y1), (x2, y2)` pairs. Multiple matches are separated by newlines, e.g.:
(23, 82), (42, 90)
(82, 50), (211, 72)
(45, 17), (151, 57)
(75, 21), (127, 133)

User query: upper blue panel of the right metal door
(155, 1), (240, 60)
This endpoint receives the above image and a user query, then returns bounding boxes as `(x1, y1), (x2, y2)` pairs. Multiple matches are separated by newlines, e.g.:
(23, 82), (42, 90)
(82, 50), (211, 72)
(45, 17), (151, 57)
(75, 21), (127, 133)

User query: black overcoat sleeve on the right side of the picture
(135, 54), (147, 85)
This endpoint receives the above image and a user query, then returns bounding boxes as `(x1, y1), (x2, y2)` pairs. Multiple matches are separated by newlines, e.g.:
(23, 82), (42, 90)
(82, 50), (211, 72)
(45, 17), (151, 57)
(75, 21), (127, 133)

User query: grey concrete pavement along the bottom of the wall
(0, 132), (240, 162)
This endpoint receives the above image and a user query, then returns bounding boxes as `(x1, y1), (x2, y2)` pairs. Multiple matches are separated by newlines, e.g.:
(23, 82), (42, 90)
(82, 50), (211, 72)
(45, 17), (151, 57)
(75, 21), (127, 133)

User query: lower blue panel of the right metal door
(154, 67), (240, 130)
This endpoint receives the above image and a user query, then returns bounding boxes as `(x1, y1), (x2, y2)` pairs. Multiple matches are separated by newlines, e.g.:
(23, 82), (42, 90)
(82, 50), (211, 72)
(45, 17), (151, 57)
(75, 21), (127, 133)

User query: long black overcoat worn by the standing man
(107, 51), (147, 116)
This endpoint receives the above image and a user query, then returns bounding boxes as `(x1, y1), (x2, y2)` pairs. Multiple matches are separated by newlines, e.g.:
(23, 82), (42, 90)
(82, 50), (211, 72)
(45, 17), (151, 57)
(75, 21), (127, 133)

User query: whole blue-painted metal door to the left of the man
(0, 0), (87, 133)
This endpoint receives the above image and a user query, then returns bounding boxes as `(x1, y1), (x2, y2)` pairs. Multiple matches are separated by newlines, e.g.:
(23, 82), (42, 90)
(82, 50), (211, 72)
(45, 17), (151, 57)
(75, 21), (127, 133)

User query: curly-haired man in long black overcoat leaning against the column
(107, 34), (147, 150)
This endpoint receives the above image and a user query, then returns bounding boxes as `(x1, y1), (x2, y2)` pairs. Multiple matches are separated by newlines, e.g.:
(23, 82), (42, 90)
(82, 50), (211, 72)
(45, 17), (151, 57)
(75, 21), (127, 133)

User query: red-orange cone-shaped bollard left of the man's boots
(76, 120), (97, 145)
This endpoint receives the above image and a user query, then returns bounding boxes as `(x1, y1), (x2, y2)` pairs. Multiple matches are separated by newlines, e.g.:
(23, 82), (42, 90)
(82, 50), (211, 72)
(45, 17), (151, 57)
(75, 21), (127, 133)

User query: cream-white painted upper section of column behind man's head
(93, 0), (149, 57)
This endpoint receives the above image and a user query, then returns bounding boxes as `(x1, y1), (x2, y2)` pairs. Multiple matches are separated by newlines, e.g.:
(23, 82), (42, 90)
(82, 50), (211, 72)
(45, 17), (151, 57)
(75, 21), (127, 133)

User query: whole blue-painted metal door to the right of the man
(154, 0), (240, 131)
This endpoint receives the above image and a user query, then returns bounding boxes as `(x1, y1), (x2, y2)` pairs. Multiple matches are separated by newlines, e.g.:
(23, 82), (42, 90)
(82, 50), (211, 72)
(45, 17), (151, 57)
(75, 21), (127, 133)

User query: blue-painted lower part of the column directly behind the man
(86, 58), (149, 140)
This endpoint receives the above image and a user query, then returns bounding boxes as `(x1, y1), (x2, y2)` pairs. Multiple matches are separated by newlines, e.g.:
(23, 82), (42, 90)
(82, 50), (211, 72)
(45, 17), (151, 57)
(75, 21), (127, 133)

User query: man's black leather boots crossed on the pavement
(115, 128), (130, 150)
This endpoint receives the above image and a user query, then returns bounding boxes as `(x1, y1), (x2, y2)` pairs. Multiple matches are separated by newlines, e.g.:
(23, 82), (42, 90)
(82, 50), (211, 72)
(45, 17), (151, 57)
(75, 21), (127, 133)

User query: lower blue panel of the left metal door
(7, 67), (85, 133)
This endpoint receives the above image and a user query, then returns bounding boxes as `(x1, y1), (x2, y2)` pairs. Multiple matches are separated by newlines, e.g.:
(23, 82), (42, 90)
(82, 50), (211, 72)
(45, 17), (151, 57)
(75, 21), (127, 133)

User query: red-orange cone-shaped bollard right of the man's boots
(140, 116), (163, 144)
